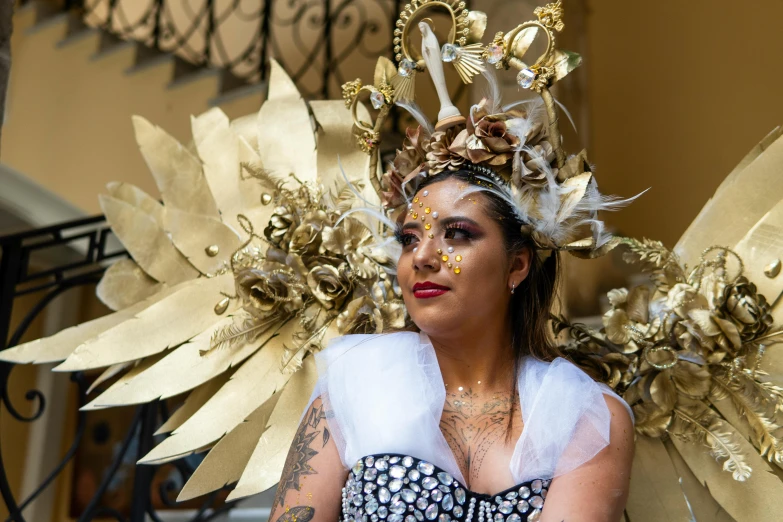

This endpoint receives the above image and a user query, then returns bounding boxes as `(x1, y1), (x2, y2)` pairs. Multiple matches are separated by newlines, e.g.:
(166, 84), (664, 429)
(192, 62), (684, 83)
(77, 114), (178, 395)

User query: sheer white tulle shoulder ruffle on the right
(511, 358), (633, 483)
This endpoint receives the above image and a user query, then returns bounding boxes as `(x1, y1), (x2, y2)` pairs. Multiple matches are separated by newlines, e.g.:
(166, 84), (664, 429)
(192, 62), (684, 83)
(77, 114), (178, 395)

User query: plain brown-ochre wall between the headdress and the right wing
(584, 0), (783, 247)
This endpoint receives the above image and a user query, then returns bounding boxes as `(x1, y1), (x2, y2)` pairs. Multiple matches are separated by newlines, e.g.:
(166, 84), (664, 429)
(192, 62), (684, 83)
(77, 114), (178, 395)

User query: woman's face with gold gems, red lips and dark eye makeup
(397, 178), (529, 337)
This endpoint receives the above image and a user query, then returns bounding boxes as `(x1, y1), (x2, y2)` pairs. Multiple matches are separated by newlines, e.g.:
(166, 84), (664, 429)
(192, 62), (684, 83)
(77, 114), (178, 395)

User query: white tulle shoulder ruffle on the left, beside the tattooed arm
(304, 332), (461, 478)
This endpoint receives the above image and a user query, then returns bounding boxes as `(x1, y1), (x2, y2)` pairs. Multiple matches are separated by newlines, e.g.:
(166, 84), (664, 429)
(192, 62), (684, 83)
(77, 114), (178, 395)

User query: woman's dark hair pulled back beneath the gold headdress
(402, 170), (562, 426)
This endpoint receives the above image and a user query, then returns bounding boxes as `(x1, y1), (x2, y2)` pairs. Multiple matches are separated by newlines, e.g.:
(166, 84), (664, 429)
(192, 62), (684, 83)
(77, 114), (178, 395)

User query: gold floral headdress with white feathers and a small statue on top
(343, 0), (630, 257)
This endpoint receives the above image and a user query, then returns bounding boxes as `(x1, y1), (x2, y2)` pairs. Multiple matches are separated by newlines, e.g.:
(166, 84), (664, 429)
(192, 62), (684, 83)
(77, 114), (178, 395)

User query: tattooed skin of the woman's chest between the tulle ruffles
(440, 388), (518, 481)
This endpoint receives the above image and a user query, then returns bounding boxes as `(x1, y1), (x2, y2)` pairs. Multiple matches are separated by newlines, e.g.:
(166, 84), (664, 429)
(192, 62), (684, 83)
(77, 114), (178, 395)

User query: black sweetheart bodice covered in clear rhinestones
(342, 454), (549, 522)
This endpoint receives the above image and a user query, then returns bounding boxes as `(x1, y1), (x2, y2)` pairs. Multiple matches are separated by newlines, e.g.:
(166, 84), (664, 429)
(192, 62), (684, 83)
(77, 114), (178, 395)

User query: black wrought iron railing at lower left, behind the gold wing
(0, 216), (240, 522)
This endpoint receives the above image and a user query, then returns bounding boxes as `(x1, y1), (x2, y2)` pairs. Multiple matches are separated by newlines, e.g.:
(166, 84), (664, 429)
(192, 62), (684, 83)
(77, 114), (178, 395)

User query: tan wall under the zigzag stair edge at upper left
(0, 8), (261, 213)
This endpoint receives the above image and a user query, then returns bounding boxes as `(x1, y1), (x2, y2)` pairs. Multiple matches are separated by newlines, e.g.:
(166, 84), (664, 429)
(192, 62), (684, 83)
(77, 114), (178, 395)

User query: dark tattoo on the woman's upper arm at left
(272, 405), (329, 506)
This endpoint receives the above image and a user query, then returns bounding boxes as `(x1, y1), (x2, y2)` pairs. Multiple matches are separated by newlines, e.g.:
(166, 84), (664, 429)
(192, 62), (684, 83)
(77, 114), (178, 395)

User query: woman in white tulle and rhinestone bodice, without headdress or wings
(270, 164), (633, 522)
